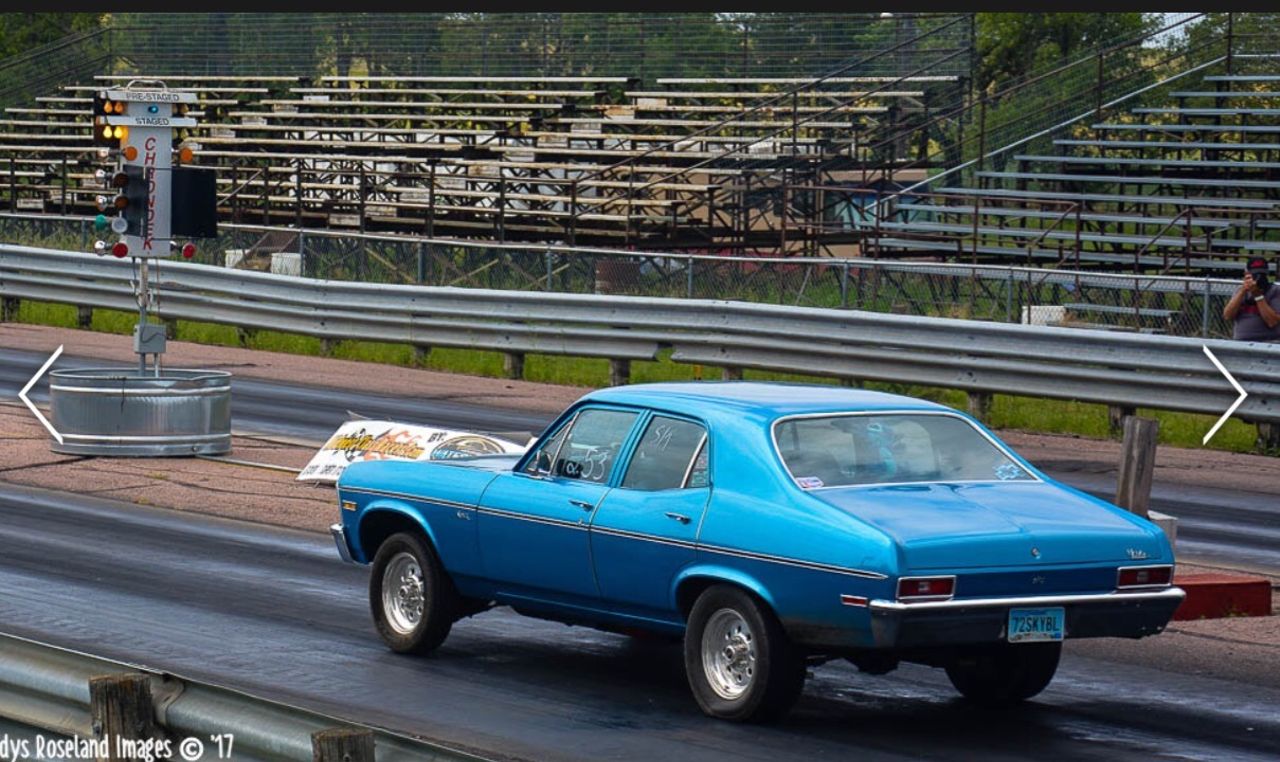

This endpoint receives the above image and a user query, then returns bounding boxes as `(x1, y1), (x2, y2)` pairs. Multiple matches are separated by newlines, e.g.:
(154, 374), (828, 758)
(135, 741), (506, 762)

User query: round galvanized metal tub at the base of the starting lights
(49, 368), (232, 457)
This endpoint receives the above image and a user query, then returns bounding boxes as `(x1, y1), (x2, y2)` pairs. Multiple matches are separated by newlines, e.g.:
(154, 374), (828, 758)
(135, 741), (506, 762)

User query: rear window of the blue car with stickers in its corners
(773, 414), (1034, 489)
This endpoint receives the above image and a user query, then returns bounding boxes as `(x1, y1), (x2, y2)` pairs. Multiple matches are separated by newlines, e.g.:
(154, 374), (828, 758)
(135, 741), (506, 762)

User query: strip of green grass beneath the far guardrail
(10, 300), (1256, 452)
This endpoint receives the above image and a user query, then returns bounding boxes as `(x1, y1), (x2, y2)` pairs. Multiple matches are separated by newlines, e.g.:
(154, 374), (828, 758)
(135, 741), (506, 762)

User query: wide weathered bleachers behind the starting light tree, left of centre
(0, 29), (959, 247)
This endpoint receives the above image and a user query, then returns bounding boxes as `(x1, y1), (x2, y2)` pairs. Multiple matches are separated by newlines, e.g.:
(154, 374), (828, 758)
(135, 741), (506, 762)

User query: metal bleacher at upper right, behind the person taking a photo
(865, 55), (1280, 275)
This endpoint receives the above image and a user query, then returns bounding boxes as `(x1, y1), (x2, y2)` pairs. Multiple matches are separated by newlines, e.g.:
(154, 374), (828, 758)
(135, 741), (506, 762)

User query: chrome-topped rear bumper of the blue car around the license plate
(868, 588), (1187, 648)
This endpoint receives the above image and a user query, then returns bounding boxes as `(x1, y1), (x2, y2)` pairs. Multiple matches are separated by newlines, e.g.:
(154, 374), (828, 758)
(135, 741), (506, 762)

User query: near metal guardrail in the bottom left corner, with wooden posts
(0, 635), (483, 762)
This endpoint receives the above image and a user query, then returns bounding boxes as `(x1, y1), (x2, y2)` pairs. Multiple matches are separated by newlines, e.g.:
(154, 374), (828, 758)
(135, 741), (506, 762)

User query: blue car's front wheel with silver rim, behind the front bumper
(369, 531), (460, 653)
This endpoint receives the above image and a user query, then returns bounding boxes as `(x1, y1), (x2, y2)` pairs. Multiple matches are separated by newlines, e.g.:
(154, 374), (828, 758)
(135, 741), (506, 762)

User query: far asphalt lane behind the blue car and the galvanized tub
(0, 348), (1280, 574)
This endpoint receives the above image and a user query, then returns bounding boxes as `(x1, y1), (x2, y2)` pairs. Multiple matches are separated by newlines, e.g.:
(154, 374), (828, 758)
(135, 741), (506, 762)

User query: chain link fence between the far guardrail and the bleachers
(0, 214), (1238, 338)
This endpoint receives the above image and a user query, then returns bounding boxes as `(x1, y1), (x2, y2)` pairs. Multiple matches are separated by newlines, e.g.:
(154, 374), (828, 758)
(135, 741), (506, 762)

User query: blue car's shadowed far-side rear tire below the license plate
(947, 643), (1062, 707)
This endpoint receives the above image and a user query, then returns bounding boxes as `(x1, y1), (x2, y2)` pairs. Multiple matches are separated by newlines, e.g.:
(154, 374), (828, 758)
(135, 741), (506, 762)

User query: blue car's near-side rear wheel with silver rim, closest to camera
(685, 585), (805, 722)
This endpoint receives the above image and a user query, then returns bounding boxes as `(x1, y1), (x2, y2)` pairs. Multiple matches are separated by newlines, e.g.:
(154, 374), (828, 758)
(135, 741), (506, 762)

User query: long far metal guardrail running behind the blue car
(0, 246), (1280, 424)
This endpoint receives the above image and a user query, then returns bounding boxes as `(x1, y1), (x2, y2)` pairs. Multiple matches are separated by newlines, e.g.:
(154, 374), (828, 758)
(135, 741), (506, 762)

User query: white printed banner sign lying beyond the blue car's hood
(298, 420), (527, 483)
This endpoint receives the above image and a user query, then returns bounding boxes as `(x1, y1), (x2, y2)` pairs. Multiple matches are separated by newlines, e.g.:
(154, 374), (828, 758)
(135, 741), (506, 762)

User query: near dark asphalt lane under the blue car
(0, 484), (1280, 762)
